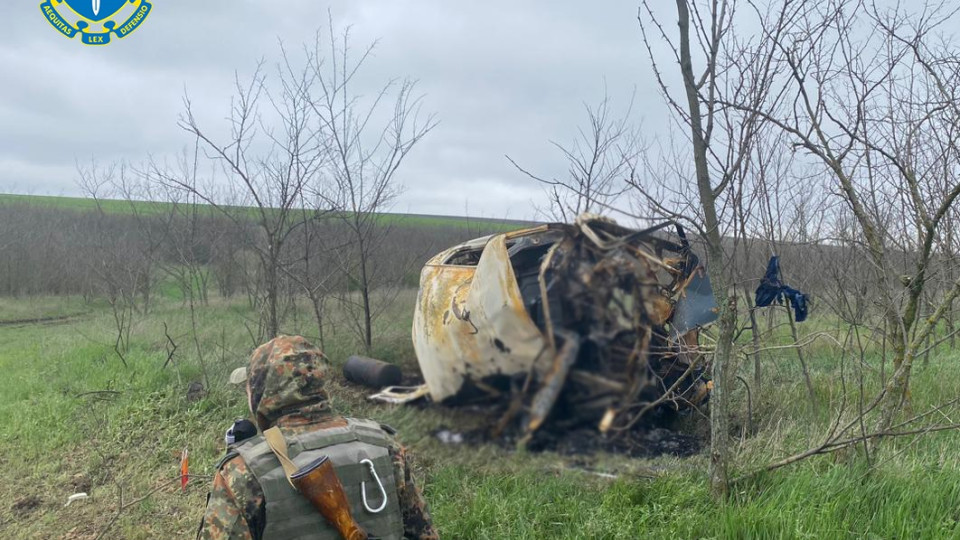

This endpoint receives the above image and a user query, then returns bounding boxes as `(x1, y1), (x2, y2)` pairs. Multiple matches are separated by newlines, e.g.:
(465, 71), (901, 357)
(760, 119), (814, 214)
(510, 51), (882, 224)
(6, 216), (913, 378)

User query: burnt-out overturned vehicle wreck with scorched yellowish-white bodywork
(384, 215), (716, 444)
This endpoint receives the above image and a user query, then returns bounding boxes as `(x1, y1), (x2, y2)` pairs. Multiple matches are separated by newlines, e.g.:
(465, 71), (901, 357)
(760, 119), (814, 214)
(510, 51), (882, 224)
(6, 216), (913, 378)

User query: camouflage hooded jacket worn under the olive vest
(197, 337), (438, 540)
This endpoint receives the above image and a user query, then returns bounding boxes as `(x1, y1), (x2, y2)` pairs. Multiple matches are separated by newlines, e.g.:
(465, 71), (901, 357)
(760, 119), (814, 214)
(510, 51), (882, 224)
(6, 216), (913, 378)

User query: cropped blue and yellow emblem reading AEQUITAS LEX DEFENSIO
(40, 0), (153, 45)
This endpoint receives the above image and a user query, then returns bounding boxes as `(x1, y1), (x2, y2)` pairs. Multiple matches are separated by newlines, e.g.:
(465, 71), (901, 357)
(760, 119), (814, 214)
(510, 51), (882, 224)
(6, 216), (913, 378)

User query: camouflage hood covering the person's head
(247, 336), (332, 429)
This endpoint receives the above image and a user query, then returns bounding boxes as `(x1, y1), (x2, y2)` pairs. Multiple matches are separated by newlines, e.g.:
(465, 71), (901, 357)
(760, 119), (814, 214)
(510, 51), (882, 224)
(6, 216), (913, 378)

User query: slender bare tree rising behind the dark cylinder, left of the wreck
(308, 21), (436, 350)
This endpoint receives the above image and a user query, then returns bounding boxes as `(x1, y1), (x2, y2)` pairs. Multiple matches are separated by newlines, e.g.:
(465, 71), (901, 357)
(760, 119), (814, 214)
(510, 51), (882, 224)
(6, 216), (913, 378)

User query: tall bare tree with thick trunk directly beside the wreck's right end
(631, 0), (771, 495)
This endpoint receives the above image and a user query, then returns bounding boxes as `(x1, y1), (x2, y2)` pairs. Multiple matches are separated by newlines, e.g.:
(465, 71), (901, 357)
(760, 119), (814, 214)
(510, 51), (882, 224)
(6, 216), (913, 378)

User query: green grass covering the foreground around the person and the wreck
(0, 291), (960, 539)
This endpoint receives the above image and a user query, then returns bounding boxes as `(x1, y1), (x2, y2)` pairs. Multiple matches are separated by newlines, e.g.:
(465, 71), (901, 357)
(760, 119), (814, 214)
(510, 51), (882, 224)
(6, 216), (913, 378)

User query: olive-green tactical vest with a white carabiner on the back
(236, 418), (403, 540)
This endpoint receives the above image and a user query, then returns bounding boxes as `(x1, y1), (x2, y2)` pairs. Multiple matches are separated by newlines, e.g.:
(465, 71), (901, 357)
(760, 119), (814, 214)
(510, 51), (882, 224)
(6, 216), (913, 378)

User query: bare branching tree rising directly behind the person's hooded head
(163, 52), (327, 338)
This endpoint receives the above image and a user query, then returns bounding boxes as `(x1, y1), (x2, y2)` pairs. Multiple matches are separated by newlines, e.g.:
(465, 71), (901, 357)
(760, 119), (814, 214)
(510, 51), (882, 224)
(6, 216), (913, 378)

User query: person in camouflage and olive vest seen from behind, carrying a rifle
(197, 337), (438, 540)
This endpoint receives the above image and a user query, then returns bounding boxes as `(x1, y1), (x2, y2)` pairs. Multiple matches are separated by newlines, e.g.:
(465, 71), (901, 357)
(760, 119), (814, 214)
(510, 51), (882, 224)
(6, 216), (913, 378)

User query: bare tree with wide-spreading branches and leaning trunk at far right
(725, 0), (960, 429)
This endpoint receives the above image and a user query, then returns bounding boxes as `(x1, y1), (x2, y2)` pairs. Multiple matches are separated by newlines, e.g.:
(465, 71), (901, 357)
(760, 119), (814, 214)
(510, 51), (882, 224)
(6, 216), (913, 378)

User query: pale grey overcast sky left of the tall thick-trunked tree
(0, 0), (669, 218)
